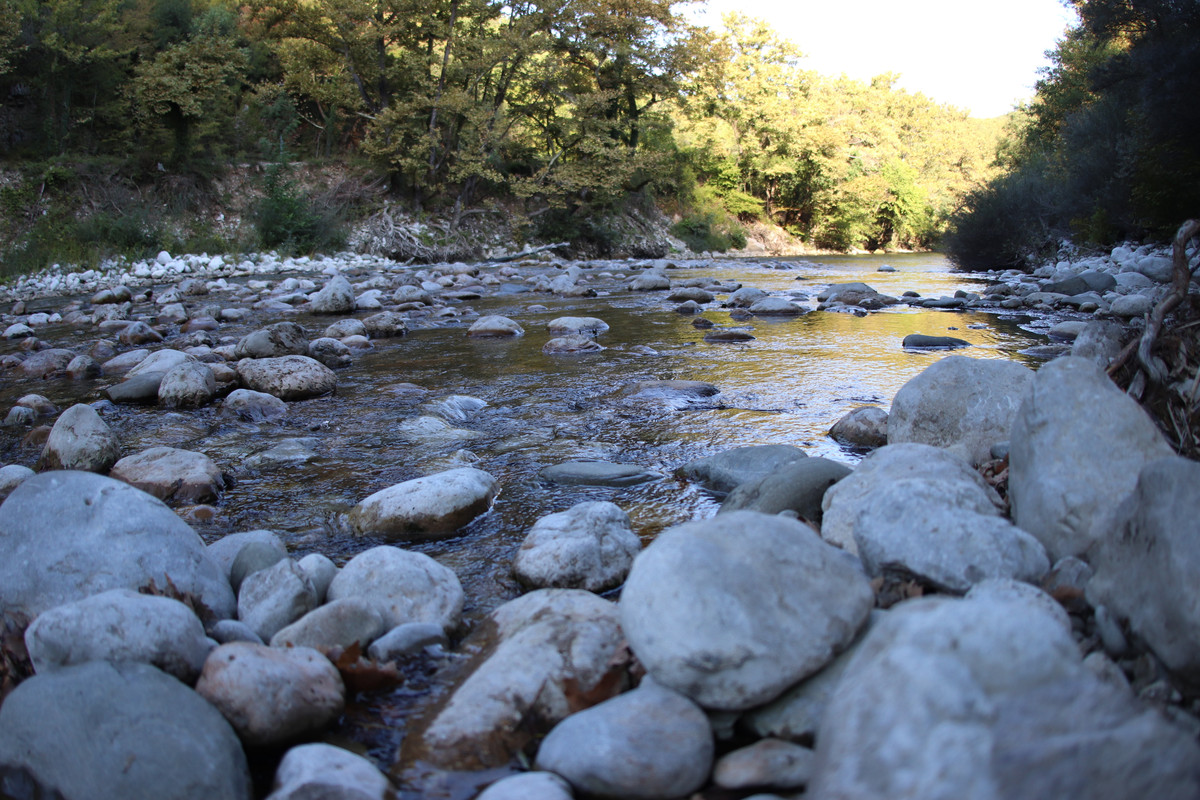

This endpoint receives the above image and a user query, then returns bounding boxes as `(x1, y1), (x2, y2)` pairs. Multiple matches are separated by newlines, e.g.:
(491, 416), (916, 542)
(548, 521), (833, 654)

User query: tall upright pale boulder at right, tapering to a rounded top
(1008, 356), (1172, 561)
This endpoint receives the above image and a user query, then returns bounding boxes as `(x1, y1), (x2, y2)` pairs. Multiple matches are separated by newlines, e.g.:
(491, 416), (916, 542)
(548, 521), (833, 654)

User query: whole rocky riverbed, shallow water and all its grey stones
(0, 247), (1200, 800)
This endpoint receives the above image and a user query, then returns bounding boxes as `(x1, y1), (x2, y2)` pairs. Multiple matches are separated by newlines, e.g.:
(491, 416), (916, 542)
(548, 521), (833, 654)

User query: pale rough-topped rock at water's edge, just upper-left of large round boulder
(512, 501), (642, 591)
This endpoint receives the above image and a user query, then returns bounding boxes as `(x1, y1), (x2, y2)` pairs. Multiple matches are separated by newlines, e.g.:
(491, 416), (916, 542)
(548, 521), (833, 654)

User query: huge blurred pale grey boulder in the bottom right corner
(805, 582), (1200, 800)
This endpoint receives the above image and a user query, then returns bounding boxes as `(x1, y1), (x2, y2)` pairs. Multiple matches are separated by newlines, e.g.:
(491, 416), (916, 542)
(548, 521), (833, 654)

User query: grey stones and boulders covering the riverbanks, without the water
(0, 241), (1200, 800)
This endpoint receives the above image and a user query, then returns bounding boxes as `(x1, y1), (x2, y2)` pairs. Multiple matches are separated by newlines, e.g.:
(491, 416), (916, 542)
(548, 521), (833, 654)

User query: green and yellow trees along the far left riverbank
(0, 0), (998, 271)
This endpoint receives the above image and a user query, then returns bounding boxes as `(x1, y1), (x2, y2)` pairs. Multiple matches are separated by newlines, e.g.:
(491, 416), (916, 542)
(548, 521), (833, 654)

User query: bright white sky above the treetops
(694, 0), (1075, 118)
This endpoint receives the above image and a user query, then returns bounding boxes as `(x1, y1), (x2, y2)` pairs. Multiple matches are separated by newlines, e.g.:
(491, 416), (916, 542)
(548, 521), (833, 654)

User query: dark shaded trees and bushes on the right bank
(948, 0), (1200, 267)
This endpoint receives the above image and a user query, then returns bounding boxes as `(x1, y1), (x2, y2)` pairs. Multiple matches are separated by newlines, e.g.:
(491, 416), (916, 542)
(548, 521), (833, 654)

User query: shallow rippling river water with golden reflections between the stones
(0, 254), (1045, 794)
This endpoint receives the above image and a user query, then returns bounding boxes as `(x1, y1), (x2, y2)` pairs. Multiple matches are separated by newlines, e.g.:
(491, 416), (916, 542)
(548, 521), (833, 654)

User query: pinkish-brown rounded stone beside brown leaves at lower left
(196, 642), (346, 745)
